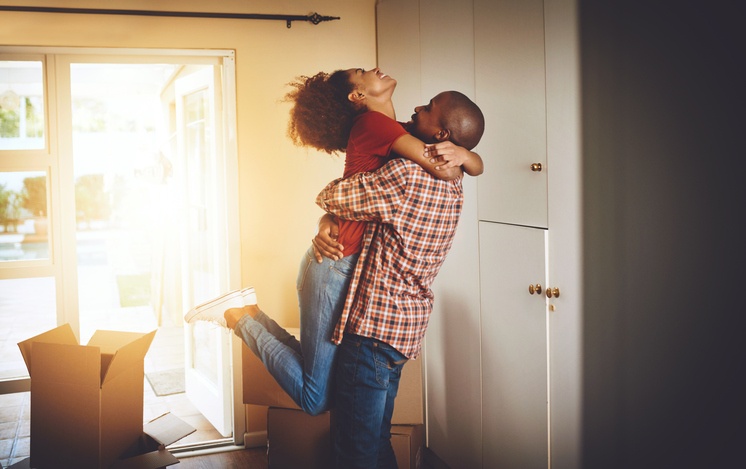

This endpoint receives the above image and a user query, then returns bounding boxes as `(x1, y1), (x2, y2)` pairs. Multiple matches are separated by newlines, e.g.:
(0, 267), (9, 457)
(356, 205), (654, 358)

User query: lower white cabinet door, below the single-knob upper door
(479, 222), (548, 469)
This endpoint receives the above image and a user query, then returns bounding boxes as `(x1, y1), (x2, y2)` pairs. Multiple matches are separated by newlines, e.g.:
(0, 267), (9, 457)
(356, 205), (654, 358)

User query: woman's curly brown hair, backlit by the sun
(285, 70), (365, 154)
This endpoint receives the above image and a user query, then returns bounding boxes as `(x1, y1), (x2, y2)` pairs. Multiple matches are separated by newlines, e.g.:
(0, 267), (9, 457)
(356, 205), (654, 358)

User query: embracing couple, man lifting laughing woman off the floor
(185, 68), (484, 469)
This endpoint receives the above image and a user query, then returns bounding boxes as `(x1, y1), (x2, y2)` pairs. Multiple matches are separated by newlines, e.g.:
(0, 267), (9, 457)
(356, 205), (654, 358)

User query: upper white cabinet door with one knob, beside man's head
(474, 0), (548, 228)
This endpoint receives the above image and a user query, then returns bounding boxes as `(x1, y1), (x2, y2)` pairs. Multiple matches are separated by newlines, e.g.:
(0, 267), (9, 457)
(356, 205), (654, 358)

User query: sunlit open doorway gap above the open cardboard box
(70, 63), (180, 342)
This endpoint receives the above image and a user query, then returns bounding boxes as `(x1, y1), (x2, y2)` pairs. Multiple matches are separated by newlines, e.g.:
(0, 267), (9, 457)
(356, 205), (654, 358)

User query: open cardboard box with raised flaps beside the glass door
(18, 324), (155, 469)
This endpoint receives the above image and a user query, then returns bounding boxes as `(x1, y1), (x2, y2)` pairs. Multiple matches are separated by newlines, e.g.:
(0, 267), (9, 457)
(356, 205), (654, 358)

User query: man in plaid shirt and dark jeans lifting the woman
(314, 91), (484, 469)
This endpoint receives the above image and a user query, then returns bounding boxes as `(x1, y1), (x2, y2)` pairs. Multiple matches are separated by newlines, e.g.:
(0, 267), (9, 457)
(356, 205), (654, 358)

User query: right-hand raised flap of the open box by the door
(88, 331), (156, 386)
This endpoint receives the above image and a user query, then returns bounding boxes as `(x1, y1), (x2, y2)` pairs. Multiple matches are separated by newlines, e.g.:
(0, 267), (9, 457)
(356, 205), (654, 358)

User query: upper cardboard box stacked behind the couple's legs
(242, 329), (425, 425)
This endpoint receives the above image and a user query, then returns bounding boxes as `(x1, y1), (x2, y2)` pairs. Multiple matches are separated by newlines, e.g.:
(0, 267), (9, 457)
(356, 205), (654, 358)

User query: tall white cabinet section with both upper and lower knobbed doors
(474, 0), (549, 469)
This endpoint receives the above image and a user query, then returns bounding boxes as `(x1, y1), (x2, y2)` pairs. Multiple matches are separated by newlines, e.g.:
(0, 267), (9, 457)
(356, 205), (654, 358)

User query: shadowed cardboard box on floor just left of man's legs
(267, 407), (332, 469)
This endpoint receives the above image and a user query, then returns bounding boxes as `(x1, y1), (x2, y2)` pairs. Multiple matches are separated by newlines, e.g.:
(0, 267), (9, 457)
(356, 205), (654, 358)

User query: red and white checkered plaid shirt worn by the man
(316, 158), (464, 358)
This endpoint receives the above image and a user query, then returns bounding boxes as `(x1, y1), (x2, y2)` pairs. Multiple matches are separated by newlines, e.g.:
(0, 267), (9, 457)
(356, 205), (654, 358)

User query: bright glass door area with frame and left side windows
(0, 48), (243, 442)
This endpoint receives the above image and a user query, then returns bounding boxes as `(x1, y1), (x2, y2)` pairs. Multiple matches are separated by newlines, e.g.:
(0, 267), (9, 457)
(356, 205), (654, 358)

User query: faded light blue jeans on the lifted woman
(234, 248), (358, 415)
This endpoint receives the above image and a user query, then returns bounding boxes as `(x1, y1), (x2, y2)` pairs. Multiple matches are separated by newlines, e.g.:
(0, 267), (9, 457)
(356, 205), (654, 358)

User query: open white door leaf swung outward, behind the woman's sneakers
(176, 68), (233, 437)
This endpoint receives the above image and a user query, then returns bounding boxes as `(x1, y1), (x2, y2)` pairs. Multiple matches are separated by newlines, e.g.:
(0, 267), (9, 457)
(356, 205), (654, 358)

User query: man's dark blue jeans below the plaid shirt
(332, 334), (407, 469)
